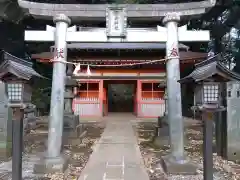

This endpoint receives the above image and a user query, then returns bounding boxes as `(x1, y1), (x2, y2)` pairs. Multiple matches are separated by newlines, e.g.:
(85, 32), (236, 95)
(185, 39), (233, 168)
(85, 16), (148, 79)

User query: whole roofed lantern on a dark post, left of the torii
(0, 51), (42, 180)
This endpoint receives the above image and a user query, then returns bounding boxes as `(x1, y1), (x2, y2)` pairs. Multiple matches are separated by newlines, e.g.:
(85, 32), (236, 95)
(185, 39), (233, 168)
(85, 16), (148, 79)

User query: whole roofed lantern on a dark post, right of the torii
(179, 55), (240, 180)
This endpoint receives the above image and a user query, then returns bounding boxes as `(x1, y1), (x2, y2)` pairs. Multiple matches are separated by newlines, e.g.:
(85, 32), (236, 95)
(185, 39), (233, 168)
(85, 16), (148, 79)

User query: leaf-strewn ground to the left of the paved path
(0, 123), (104, 180)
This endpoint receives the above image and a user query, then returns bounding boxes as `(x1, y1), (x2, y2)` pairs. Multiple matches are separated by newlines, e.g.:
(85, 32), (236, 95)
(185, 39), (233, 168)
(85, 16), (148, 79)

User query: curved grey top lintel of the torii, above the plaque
(18, 0), (216, 21)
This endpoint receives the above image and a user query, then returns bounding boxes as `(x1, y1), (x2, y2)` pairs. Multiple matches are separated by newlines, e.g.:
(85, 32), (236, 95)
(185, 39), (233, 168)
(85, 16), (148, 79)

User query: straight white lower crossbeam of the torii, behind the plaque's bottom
(25, 25), (210, 43)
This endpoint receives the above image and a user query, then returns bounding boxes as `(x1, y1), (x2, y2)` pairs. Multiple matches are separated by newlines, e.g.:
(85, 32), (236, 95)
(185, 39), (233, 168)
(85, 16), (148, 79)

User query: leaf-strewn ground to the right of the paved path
(137, 123), (240, 180)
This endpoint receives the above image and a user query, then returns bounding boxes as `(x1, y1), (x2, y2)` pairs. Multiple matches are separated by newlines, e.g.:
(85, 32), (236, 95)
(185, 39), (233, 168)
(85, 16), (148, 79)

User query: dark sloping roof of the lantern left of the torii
(0, 51), (44, 80)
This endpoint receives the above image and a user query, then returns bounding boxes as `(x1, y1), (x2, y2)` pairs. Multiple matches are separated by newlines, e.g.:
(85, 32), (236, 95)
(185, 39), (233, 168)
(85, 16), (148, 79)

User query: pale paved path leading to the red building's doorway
(78, 118), (149, 180)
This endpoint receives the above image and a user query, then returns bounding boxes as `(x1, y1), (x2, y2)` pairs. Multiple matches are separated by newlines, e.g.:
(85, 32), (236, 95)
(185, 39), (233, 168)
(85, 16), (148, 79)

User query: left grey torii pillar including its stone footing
(34, 14), (71, 173)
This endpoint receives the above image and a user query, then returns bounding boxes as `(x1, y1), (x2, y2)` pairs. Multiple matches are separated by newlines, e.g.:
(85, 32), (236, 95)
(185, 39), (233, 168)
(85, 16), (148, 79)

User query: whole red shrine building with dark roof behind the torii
(32, 42), (207, 118)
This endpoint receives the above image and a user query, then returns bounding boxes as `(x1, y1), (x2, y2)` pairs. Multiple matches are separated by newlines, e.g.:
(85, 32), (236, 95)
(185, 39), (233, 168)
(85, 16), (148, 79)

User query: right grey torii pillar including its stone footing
(163, 13), (196, 174)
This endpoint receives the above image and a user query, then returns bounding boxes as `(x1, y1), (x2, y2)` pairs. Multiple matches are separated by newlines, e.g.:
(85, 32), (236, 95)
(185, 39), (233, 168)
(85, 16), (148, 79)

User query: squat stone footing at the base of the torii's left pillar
(33, 156), (68, 174)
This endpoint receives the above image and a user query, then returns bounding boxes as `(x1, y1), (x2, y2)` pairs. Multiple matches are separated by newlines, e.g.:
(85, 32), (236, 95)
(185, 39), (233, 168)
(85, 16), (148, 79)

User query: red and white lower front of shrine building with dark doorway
(73, 79), (165, 120)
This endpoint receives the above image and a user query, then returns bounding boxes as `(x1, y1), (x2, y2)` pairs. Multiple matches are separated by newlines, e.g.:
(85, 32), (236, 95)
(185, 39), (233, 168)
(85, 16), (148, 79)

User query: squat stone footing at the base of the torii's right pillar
(162, 155), (197, 175)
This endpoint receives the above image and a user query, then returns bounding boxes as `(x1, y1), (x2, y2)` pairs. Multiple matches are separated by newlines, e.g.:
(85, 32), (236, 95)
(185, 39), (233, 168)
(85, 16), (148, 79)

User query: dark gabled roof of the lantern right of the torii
(178, 54), (240, 83)
